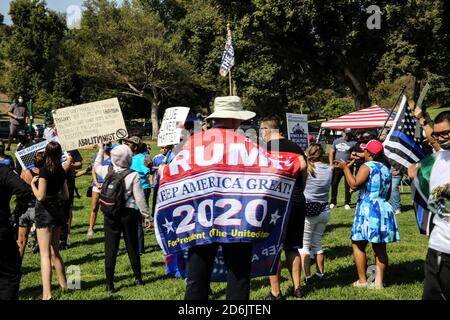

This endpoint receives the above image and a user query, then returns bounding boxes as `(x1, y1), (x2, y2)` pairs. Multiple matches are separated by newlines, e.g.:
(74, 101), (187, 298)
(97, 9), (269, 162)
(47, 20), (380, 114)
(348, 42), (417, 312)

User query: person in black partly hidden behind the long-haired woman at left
(60, 150), (83, 250)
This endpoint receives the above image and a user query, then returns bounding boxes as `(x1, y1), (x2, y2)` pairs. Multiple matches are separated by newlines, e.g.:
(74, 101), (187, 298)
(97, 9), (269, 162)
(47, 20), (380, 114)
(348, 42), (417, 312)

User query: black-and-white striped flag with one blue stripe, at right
(383, 96), (426, 170)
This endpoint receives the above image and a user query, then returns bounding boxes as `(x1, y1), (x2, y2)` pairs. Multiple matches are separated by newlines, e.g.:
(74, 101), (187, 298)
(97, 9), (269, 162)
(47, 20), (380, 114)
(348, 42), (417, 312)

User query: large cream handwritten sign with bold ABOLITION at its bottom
(52, 98), (128, 150)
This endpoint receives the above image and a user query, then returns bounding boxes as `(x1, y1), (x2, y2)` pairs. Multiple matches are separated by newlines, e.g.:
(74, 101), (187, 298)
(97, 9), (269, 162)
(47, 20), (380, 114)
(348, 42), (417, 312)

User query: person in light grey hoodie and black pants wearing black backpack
(94, 144), (149, 293)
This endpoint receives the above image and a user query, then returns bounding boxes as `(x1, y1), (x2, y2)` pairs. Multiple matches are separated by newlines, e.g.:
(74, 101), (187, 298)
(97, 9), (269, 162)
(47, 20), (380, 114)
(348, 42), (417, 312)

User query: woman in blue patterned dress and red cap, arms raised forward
(337, 140), (400, 289)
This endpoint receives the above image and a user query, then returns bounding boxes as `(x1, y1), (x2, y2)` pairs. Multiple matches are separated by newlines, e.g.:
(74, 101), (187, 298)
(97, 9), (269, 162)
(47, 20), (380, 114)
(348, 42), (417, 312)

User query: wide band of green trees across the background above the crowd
(0, 0), (450, 130)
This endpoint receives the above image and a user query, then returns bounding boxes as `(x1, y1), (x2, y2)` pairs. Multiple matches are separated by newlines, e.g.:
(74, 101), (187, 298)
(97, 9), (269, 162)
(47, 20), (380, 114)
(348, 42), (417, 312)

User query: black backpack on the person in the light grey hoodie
(99, 166), (133, 217)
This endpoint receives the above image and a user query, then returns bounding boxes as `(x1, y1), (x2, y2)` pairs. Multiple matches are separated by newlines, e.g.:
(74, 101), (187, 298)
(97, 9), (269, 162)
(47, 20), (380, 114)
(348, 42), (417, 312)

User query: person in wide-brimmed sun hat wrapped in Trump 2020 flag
(155, 96), (306, 300)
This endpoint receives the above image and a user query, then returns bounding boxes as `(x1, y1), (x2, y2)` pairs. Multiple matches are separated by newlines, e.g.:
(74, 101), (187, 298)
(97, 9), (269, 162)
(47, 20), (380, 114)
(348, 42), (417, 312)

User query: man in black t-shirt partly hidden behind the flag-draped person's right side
(260, 116), (307, 300)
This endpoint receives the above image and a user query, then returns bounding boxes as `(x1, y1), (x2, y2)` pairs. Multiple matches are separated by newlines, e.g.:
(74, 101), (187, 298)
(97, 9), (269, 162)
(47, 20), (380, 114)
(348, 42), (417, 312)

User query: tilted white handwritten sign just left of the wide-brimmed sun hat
(158, 107), (189, 147)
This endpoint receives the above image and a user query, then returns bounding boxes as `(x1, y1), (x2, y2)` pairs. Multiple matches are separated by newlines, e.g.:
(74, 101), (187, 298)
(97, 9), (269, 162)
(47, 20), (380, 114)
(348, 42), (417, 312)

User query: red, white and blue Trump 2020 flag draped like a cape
(155, 128), (301, 281)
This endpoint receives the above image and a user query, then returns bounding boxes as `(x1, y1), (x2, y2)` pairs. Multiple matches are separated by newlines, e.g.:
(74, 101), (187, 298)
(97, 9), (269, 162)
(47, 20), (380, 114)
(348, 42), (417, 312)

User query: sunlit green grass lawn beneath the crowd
(14, 140), (428, 300)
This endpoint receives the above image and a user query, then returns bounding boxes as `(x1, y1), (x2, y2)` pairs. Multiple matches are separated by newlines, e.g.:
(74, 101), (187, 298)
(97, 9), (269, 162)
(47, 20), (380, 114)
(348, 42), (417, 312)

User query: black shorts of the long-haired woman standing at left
(35, 199), (64, 229)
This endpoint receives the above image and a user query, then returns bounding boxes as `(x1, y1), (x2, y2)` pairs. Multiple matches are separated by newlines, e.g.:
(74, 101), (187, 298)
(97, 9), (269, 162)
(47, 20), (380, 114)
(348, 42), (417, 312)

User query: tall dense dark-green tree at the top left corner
(5, 0), (66, 102)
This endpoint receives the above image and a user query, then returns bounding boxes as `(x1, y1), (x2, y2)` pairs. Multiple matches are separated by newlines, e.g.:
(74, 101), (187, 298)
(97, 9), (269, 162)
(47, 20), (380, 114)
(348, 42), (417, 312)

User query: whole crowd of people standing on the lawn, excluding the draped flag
(0, 96), (450, 300)
